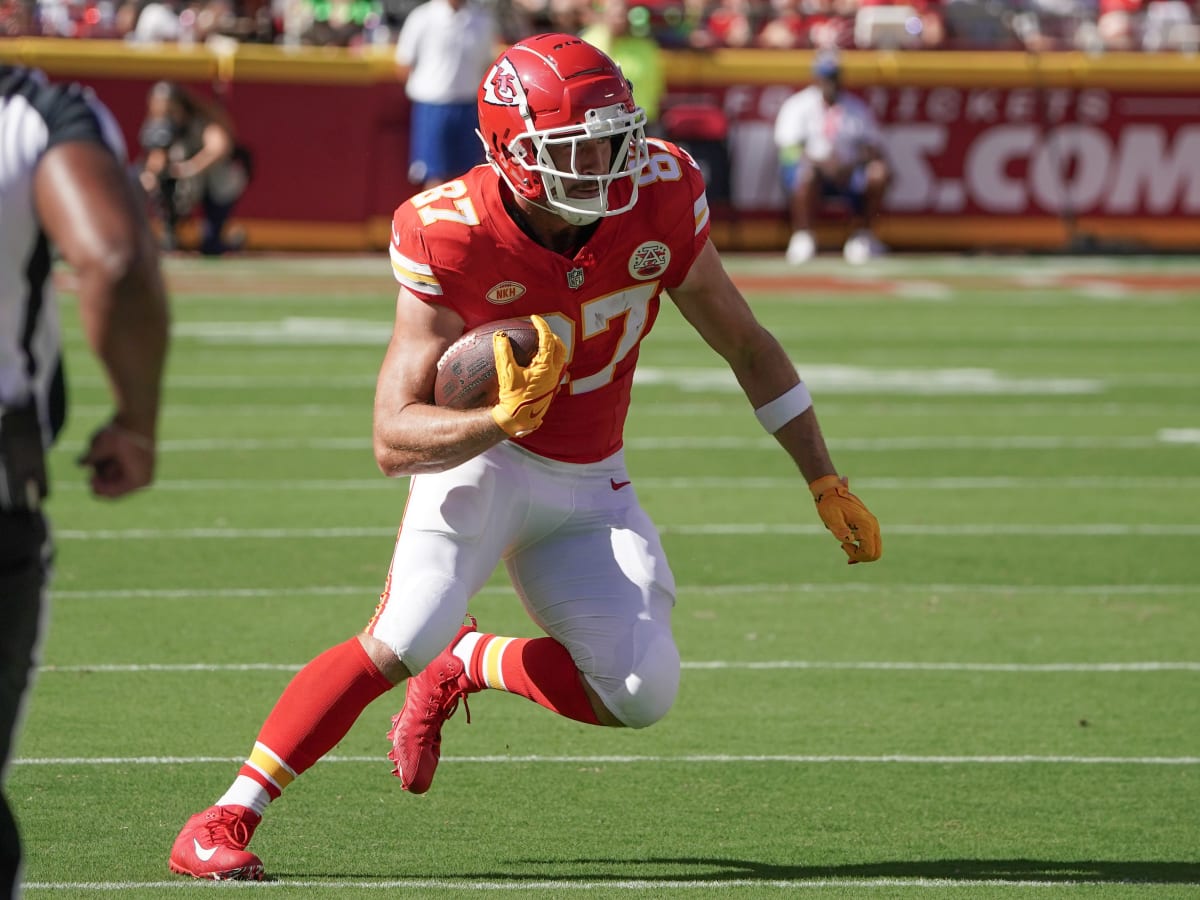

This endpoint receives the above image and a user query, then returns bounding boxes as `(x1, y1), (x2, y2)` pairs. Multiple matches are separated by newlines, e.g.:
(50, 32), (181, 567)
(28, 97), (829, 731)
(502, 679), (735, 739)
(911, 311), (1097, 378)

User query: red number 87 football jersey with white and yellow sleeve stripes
(390, 140), (709, 462)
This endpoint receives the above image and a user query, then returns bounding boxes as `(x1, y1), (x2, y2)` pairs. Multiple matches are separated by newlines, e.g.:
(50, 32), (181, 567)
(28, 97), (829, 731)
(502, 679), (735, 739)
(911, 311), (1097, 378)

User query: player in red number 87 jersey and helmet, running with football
(170, 34), (880, 878)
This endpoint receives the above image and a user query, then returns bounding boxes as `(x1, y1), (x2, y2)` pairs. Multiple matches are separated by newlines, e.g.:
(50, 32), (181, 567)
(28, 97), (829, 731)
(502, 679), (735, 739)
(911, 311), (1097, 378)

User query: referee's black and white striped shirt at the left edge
(0, 65), (126, 446)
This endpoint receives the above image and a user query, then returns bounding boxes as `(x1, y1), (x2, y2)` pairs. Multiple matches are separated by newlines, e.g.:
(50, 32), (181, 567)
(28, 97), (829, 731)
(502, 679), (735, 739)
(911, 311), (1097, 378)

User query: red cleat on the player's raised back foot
(388, 616), (480, 793)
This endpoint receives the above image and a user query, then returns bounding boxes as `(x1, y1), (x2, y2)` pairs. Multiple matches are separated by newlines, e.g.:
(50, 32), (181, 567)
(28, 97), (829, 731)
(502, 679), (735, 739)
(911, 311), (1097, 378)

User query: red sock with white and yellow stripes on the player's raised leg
(467, 635), (600, 725)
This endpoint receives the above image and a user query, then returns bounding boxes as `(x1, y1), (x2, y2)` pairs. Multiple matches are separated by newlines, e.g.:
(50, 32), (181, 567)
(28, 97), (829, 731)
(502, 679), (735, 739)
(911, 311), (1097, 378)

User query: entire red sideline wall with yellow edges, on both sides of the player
(0, 38), (1200, 250)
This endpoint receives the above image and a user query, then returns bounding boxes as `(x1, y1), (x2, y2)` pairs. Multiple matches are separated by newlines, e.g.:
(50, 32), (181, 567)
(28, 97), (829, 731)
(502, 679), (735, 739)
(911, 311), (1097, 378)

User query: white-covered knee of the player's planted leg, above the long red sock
(368, 574), (468, 674)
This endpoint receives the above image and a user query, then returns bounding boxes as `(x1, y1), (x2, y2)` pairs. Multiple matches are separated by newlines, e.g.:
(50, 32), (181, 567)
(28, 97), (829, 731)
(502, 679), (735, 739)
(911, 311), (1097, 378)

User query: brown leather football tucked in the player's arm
(433, 318), (538, 409)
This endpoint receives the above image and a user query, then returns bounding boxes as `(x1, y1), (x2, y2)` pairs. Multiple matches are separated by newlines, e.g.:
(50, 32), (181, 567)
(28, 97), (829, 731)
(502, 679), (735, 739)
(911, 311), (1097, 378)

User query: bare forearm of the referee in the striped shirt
(77, 251), (169, 439)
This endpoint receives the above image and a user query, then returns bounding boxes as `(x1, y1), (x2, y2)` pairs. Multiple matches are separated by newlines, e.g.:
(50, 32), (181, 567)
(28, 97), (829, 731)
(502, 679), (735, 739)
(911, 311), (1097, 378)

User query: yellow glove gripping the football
(492, 316), (566, 438)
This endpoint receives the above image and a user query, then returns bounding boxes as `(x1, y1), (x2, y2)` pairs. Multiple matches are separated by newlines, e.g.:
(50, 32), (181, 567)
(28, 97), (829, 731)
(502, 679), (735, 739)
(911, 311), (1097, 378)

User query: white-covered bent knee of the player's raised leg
(593, 622), (679, 728)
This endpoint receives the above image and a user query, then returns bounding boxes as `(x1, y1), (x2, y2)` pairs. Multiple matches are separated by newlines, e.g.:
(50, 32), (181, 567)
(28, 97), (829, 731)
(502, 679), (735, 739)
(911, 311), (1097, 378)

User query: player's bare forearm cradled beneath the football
(374, 403), (508, 478)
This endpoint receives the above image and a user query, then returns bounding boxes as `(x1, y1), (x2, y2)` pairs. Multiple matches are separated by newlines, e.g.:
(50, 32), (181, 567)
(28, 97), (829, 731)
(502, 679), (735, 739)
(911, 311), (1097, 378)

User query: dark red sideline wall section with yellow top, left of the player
(0, 38), (412, 250)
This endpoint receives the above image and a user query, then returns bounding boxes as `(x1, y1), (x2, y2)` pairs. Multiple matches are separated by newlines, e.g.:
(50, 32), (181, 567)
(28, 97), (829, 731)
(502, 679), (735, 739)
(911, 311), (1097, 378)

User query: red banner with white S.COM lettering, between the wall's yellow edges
(696, 85), (1200, 224)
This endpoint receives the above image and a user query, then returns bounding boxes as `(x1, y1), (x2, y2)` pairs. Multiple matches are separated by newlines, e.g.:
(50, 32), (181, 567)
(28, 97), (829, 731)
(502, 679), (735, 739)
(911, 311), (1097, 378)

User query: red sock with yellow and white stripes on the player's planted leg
(238, 637), (392, 799)
